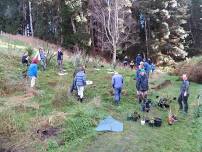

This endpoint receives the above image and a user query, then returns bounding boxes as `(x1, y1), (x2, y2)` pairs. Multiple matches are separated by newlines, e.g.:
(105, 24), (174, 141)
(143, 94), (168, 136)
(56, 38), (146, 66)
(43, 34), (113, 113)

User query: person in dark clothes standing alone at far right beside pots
(178, 74), (189, 113)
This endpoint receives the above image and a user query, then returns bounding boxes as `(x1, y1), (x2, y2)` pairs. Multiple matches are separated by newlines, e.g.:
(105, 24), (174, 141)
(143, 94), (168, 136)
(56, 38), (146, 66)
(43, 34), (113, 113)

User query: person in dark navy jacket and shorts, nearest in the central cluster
(136, 69), (149, 103)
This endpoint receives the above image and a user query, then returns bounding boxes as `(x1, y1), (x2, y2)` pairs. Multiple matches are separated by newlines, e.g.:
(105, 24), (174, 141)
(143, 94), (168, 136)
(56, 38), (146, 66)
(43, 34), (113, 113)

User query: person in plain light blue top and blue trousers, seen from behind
(112, 72), (124, 105)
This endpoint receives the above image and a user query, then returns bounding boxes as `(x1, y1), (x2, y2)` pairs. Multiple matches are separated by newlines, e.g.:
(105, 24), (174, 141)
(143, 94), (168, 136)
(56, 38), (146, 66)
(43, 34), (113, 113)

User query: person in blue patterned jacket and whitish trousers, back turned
(74, 68), (86, 102)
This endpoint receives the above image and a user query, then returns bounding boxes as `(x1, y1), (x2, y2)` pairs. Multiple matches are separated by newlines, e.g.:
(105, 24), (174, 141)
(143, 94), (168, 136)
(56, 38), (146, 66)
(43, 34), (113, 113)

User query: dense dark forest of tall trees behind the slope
(0, 0), (202, 62)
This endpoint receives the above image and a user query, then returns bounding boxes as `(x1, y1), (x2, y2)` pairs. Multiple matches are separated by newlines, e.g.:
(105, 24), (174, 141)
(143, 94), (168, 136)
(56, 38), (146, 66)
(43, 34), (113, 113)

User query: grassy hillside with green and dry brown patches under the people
(0, 36), (202, 152)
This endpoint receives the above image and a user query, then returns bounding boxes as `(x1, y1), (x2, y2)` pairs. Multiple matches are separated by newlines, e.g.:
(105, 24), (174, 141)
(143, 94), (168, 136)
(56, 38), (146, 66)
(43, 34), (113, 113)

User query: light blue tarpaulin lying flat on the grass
(96, 116), (123, 132)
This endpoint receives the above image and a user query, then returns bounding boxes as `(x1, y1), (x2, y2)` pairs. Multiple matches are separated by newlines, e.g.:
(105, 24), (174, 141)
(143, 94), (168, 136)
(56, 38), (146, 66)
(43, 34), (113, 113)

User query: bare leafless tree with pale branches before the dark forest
(89, 0), (135, 65)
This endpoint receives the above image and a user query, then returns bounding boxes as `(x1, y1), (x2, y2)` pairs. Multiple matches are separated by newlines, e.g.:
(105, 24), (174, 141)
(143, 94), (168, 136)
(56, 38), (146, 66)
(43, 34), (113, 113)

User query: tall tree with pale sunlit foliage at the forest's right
(134, 0), (189, 60)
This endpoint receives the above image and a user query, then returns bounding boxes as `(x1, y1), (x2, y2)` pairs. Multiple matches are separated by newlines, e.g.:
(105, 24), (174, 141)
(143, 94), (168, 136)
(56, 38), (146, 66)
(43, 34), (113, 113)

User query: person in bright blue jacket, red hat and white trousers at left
(27, 59), (38, 88)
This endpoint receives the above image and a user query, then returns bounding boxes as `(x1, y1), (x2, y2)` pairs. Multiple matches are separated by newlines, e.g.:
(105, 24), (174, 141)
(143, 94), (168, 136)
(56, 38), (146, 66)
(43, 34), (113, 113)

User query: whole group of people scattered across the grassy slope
(22, 48), (189, 113)
